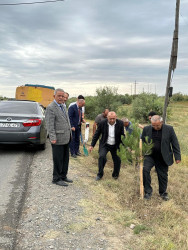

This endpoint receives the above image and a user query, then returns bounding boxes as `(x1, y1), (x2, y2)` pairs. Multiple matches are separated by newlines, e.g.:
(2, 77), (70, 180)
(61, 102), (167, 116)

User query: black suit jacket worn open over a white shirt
(91, 119), (125, 150)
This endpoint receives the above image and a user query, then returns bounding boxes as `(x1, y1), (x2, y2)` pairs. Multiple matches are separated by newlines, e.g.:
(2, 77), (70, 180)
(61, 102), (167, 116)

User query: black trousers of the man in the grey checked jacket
(52, 144), (69, 182)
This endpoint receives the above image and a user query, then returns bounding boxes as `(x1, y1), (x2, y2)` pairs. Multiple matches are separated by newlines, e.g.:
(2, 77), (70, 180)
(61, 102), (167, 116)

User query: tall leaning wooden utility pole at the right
(163, 0), (180, 123)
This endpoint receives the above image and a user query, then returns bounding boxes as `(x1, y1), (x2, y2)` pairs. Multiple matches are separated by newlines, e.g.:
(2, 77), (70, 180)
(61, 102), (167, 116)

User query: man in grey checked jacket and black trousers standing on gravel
(46, 89), (73, 186)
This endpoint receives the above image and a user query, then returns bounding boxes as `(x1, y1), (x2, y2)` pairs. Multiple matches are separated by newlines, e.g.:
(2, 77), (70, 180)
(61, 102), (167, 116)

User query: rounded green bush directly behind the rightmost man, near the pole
(132, 93), (163, 122)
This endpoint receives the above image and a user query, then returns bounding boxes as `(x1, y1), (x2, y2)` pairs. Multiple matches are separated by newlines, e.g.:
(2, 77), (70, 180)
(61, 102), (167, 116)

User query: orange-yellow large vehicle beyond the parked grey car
(15, 84), (55, 108)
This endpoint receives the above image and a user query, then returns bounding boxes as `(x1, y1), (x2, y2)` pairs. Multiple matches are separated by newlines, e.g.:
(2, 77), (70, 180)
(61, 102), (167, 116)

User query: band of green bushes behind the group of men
(67, 86), (167, 122)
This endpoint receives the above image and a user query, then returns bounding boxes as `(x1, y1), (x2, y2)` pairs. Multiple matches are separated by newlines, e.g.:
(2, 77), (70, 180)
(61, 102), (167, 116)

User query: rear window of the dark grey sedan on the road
(0, 101), (38, 114)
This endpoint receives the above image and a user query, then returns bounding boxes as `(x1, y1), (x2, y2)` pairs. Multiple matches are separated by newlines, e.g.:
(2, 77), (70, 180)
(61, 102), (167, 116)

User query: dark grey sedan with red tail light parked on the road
(0, 100), (47, 150)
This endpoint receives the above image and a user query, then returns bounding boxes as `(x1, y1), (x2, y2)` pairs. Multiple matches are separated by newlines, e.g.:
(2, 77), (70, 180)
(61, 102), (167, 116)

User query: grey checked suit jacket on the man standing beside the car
(45, 101), (71, 145)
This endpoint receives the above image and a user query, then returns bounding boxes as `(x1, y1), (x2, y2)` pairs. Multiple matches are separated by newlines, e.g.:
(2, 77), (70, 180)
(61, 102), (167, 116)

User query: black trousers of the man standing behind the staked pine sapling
(143, 156), (168, 194)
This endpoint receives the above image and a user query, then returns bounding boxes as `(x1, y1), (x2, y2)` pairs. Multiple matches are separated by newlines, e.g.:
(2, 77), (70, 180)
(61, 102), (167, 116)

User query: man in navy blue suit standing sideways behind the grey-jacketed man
(68, 95), (85, 158)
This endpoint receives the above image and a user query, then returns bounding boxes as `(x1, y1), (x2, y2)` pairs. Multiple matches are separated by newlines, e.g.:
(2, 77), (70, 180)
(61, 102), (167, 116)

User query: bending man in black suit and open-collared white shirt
(89, 111), (124, 181)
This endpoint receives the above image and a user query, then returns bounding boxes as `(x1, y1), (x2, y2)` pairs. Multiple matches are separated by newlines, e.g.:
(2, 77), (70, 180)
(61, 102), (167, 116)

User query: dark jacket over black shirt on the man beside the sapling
(142, 124), (181, 166)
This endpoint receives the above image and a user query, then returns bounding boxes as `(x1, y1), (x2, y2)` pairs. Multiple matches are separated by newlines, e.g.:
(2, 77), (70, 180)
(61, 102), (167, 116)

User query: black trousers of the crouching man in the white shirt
(97, 144), (121, 177)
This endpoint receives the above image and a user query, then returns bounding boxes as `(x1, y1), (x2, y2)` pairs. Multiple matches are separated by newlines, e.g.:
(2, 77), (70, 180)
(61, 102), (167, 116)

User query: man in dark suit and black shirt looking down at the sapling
(142, 115), (181, 200)
